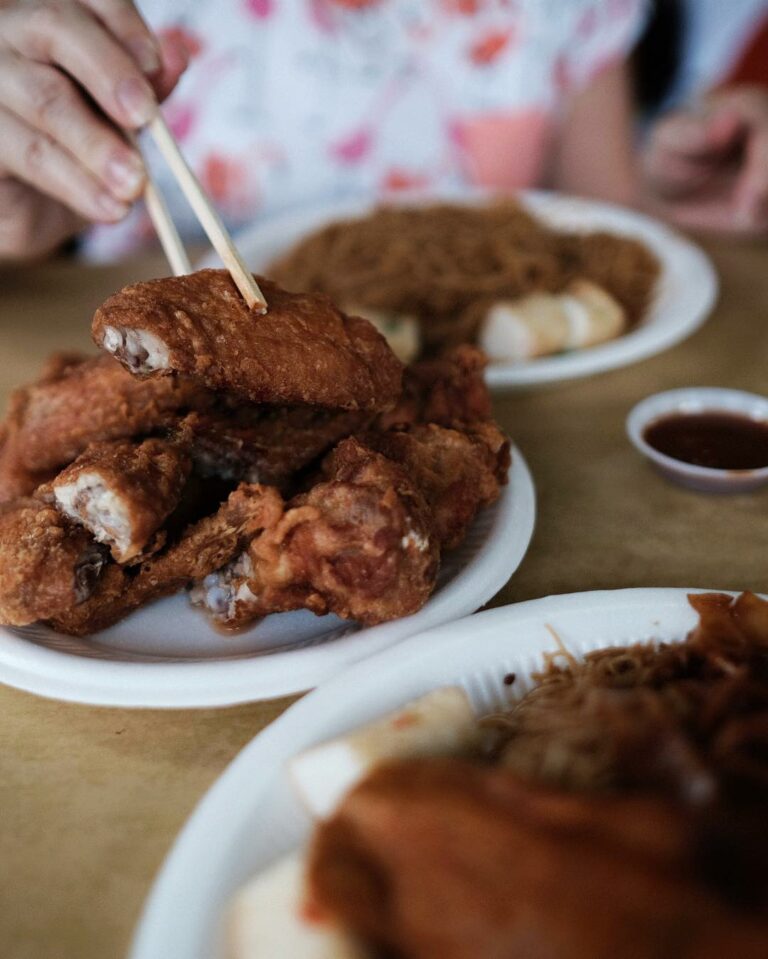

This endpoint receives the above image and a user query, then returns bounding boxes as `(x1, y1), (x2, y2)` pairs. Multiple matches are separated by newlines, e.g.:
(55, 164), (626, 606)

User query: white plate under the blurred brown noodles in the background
(198, 190), (718, 390)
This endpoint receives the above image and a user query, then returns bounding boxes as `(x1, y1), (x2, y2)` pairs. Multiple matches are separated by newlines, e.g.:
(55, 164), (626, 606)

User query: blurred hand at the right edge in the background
(643, 85), (768, 236)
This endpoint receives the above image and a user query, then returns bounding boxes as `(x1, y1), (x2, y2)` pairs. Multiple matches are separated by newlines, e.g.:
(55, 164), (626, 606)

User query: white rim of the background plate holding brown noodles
(196, 187), (720, 392)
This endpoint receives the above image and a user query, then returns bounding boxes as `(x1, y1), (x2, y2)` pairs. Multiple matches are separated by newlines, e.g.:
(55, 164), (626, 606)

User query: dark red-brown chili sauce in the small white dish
(643, 412), (768, 470)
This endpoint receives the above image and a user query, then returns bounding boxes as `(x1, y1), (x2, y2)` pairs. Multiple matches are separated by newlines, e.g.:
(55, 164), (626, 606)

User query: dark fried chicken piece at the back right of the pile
(377, 344), (493, 429)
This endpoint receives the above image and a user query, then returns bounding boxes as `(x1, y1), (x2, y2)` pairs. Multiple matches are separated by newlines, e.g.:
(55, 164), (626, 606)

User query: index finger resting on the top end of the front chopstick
(4, 0), (157, 129)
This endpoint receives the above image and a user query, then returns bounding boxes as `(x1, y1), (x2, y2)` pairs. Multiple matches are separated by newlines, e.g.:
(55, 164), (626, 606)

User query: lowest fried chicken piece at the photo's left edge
(0, 498), (106, 626)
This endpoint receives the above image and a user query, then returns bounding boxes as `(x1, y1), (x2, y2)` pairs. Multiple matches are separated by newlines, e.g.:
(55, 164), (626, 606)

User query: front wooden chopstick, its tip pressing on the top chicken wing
(147, 110), (267, 313)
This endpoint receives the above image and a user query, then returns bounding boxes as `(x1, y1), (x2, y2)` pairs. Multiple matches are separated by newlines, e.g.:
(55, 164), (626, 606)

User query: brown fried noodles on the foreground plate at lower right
(484, 593), (768, 805)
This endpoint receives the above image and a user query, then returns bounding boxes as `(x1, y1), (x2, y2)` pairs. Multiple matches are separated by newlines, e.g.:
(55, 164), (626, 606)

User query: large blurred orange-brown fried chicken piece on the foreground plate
(308, 759), (768, 959)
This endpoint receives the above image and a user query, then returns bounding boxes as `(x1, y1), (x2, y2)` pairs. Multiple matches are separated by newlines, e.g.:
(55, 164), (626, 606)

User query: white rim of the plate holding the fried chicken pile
(0, 445), (536, 709)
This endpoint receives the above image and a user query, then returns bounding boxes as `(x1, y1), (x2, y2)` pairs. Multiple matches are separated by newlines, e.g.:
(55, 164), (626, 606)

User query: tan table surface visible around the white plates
(0, 243), (768, 959)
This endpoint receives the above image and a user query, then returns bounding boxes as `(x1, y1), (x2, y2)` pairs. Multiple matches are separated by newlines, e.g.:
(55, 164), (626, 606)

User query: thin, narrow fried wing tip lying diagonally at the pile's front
(51, 484), (283, 636)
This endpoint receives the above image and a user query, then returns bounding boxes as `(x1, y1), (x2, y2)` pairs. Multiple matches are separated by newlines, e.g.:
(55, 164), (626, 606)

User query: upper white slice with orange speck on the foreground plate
(288, 686), (479, 818)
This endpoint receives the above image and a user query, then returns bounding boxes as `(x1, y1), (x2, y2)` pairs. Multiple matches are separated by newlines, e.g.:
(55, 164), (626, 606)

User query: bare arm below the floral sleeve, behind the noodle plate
(553, 62), (640, 206)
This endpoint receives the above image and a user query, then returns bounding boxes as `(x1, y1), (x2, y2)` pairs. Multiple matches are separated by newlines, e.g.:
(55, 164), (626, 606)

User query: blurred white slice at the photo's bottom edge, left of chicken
(227, 852), (370, 959)
